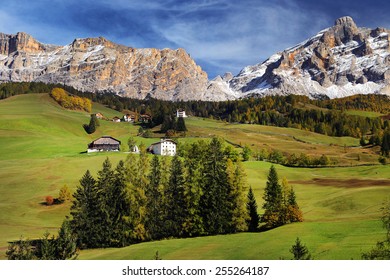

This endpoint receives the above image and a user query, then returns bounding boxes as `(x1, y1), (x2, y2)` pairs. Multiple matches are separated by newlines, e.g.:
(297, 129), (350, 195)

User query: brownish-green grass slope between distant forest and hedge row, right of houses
(186, 118), (378, 166)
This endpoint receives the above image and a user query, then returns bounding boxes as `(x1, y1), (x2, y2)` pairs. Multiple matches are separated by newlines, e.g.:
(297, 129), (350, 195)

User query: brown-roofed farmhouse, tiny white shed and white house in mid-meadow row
(87, 136), (177, 156)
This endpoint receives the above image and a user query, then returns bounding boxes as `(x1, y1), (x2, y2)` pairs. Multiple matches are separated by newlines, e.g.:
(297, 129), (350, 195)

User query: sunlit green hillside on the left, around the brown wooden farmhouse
(0, 94), (136, 258)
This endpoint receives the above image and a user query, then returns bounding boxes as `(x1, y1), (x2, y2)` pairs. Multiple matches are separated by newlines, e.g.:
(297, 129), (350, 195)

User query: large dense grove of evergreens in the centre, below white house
(67, 138), (249, 248)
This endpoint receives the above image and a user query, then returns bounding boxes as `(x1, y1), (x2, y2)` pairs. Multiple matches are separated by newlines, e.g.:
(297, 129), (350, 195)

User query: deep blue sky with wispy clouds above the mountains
(0, 0), (390, 79)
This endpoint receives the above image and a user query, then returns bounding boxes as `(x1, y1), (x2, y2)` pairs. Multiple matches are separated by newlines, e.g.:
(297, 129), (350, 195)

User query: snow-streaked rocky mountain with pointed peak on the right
(214, 17), (390, 98)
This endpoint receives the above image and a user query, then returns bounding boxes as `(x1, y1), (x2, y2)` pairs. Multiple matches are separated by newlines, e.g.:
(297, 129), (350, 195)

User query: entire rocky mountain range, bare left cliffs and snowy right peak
(0, 17), (390, 101)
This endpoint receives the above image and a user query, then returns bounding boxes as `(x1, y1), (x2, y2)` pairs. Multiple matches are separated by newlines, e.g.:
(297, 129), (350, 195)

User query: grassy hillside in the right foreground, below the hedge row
(80, 162), (390, 260)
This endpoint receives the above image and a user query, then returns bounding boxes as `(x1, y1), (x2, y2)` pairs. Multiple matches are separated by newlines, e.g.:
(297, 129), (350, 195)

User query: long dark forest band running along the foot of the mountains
(0, 83), (390, 145)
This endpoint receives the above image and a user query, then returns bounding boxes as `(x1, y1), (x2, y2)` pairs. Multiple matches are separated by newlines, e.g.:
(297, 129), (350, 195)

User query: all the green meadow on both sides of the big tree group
(0, 94), (390, 259)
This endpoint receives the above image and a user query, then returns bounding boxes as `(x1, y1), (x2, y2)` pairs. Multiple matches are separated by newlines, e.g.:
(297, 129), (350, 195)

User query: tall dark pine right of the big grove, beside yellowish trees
(261, 165), (283, 228)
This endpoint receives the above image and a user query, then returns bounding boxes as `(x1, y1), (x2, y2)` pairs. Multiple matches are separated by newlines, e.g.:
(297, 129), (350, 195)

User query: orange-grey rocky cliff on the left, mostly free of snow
(0, 33), (210, 100)
